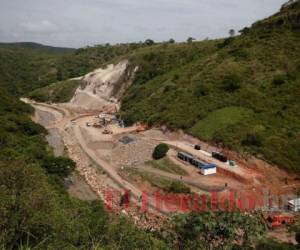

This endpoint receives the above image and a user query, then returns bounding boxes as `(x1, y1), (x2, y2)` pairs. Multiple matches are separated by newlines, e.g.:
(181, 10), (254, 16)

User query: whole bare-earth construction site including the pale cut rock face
(23, 61), (300, 238)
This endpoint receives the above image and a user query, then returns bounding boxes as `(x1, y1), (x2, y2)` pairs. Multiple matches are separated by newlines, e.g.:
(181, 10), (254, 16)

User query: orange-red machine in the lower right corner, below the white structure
(264, 213), (295, 229)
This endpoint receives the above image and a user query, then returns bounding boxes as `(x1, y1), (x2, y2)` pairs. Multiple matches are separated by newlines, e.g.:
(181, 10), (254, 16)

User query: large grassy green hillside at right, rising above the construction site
(122, 1), (300, 171)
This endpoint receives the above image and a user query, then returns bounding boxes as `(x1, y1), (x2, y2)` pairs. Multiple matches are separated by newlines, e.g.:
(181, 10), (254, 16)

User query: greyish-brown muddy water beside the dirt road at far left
(35, 107), (65, 156)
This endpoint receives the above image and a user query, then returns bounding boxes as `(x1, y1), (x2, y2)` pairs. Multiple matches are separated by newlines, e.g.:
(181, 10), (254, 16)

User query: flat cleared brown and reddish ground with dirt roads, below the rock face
(27, 98), (299, 220)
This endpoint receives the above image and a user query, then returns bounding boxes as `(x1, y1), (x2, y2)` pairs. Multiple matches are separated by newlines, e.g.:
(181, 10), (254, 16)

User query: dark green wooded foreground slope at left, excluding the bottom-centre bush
(0, 90), (166, 249)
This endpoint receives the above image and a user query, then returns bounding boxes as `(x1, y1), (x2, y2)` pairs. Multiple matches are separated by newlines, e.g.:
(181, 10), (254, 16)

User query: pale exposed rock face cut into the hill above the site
(71, 60), (134, 110)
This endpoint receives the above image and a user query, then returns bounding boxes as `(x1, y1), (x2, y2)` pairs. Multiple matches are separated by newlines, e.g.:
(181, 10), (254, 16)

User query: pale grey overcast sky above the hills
(0, 0), (287, 47)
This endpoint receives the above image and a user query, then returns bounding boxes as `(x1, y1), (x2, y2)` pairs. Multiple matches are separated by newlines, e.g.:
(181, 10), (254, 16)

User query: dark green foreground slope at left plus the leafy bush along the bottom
(0, 87), (270, 250)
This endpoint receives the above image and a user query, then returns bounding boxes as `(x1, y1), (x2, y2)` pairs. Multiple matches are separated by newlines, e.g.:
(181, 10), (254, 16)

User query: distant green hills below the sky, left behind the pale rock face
(0, 43), (147, 96)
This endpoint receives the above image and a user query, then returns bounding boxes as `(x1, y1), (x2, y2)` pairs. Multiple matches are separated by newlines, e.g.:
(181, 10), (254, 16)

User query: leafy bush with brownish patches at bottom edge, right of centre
(173, 212), (265, 249)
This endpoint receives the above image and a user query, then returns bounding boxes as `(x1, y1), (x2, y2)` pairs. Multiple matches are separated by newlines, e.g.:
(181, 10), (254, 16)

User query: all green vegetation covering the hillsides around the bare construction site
(0, 1), (300, 249)
